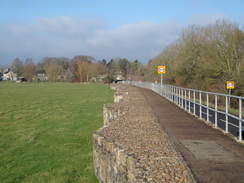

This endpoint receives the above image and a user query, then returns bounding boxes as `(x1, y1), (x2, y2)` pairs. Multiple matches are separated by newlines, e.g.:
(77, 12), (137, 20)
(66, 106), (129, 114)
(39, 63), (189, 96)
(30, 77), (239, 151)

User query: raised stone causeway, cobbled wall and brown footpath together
(93, 84), (244, 183)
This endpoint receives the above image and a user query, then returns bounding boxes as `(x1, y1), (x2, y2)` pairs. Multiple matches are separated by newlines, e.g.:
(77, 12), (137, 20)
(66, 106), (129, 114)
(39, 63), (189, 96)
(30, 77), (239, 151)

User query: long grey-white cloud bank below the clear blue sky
(0, 17), (181, 63)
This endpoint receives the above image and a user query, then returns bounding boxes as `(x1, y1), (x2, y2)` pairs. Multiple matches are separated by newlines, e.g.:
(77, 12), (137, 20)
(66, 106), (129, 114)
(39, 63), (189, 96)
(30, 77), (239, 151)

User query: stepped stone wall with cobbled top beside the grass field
(93, 84), (195, 183)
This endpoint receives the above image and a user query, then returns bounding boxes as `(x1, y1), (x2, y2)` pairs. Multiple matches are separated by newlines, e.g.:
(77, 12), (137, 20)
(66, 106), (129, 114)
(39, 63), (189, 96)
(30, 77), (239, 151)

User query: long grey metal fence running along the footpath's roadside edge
(122, 81), (244, 141)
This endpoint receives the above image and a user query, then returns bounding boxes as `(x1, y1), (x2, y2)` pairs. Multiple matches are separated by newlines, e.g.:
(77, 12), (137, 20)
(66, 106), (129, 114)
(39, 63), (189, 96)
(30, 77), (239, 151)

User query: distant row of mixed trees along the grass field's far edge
(11, 55), (145, 83)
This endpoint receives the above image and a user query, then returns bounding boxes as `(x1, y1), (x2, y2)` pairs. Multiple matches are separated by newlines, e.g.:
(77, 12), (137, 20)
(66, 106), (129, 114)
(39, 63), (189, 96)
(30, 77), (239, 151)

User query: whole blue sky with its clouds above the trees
(0, 0), (244, 66)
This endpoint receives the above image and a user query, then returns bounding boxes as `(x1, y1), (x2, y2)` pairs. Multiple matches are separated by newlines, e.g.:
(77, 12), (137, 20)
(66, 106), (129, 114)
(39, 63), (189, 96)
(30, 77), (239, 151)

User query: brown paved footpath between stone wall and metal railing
(140, 86), (244, 183)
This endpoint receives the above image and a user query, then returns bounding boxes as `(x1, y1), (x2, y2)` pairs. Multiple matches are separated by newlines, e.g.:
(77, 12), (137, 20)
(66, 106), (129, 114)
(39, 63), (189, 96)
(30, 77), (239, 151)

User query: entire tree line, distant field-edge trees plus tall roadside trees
(5, 20), (244, 96)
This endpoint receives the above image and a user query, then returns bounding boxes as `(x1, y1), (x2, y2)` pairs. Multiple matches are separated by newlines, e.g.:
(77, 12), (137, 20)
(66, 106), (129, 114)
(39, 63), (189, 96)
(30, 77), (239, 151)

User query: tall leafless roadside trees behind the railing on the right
(147, 20), (244, 96)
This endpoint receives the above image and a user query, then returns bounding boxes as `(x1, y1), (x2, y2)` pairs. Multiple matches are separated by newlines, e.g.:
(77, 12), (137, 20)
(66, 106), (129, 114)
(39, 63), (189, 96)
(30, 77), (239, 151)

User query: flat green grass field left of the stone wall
(0, 82), (113, 183)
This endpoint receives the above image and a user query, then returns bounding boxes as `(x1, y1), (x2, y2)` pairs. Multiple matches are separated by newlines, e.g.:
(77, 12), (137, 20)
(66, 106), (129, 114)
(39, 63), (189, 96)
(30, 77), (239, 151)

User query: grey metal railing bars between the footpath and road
(121, 81), (244, 141)
